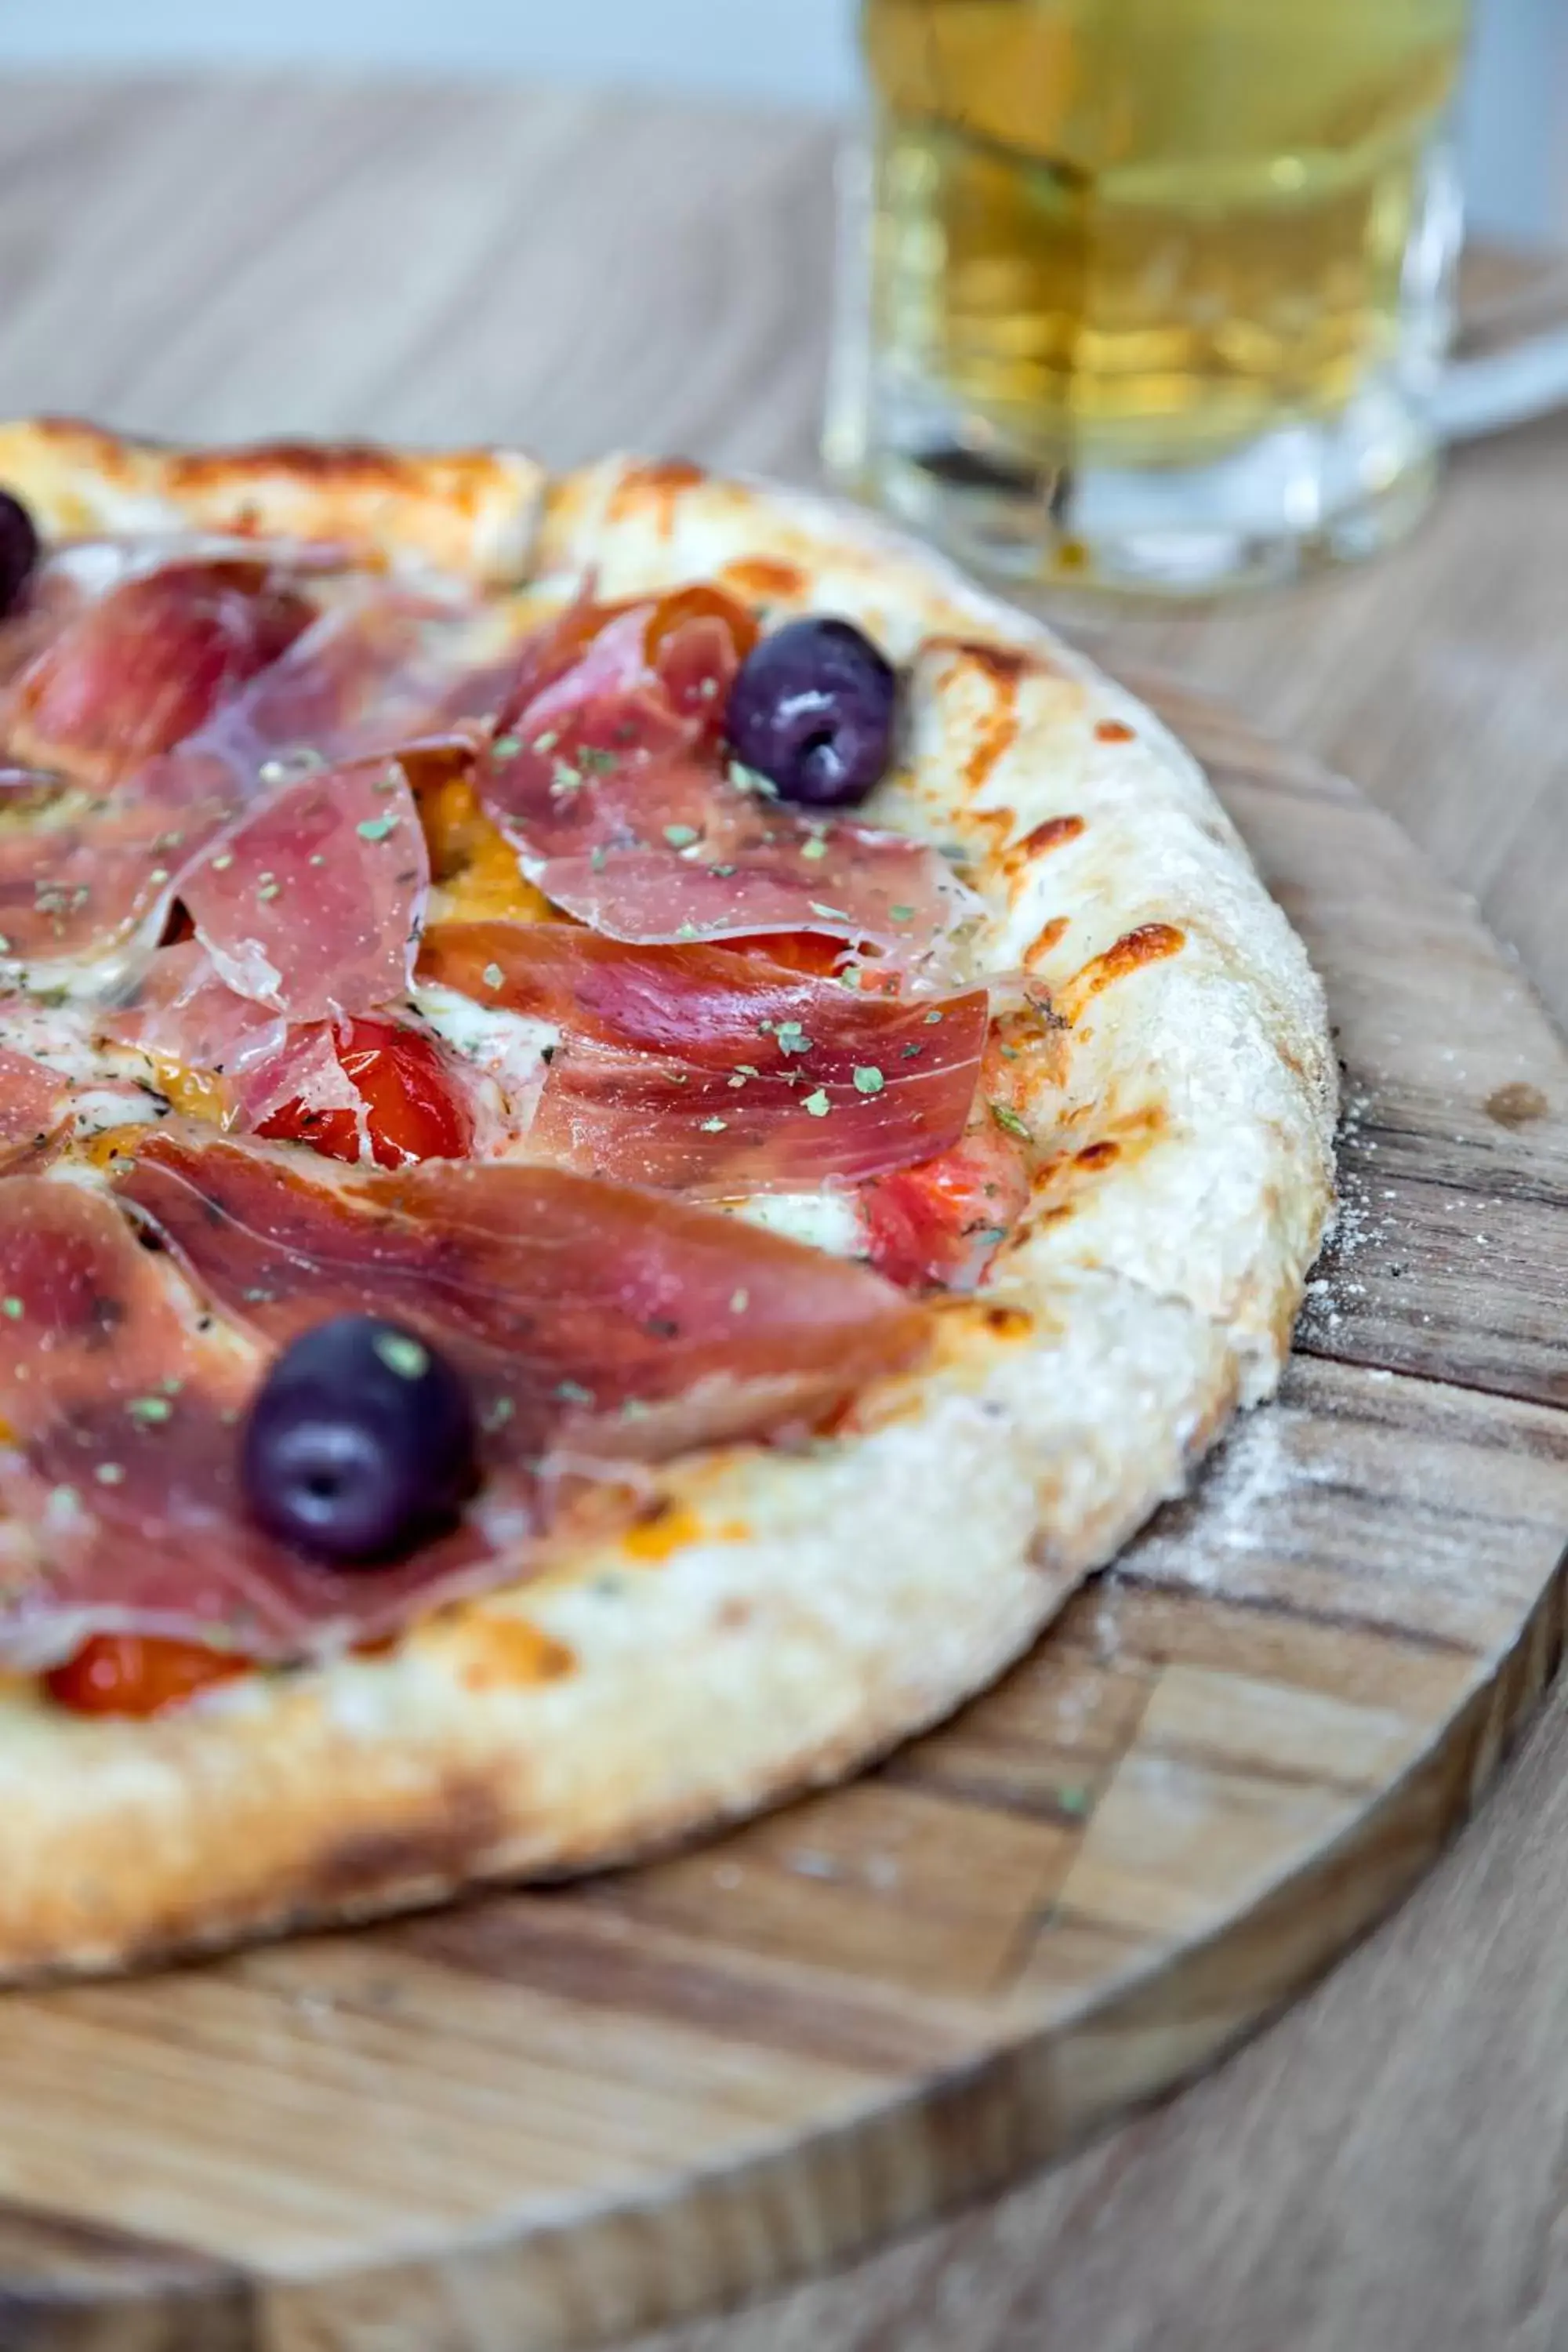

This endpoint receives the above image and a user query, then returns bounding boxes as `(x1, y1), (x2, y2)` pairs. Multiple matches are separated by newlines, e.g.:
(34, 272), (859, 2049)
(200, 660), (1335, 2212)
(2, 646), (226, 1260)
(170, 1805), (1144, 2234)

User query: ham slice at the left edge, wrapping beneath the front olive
(0, 1176), (510, 1668)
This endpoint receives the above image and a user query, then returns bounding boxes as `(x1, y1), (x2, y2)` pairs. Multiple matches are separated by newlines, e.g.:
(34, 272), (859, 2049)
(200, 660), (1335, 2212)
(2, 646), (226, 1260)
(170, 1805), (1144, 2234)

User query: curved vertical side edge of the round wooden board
(201, 1458), (1568, 2352)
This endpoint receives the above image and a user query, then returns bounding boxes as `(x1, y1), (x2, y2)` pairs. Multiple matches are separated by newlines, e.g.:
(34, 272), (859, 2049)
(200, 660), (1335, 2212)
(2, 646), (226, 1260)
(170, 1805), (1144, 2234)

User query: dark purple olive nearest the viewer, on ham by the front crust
(242, 1315), (475, 1566)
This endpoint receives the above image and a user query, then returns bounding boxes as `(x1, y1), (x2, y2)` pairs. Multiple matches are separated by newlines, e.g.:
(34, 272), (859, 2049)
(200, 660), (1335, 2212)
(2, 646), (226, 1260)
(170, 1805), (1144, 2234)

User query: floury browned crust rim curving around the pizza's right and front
(0, 428), (1335, 1976)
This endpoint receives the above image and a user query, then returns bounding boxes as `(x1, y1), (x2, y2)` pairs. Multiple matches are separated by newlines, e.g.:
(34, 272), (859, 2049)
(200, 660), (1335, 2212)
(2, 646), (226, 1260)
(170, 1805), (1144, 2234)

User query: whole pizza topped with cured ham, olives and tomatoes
(0, 421), (1335, 1980)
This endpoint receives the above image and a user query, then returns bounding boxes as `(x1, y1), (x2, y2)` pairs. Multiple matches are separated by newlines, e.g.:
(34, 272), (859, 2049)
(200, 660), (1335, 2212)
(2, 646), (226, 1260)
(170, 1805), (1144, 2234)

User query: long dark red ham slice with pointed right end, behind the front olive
(120, 1131), (926, 1465)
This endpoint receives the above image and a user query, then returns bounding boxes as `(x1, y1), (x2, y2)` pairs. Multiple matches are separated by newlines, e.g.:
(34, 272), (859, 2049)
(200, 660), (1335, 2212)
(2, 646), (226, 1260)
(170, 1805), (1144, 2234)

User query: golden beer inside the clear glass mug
(841, 0), (1467, 597)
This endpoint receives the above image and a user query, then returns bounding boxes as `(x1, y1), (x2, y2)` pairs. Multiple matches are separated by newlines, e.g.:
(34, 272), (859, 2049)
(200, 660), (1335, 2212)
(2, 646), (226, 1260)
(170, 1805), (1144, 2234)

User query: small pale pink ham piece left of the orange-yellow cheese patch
(179, 762), (430, 1021)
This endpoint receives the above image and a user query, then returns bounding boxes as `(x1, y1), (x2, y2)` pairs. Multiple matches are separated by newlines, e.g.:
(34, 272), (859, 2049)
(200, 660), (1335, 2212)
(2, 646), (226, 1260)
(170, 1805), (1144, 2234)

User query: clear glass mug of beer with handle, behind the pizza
(825, 0), (1568, 595)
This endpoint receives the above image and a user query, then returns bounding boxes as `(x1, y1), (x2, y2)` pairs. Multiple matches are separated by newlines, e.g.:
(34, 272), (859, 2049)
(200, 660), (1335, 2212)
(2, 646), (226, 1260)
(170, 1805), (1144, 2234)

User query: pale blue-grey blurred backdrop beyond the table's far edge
(0, 0), (1568, 240)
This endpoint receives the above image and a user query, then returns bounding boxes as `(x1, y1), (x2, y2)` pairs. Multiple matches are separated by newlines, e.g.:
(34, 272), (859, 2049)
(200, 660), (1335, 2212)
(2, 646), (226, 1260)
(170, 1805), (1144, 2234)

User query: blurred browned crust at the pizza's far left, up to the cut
(0, 416), (546, 588)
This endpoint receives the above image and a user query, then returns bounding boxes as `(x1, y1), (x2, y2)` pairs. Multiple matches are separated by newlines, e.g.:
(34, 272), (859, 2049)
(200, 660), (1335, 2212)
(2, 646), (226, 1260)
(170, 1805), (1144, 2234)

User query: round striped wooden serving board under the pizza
(0, 684), (1568, 2352)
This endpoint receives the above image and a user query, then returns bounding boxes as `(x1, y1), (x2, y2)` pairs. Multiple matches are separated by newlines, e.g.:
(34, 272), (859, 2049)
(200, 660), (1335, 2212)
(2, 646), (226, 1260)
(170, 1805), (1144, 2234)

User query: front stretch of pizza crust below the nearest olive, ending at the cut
(0, 1275), (1234, 1978)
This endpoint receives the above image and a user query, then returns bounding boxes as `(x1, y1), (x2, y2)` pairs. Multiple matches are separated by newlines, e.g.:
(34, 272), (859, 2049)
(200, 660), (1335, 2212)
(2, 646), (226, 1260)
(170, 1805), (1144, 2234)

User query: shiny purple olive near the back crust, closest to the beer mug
(724, 621), (898, 809)
